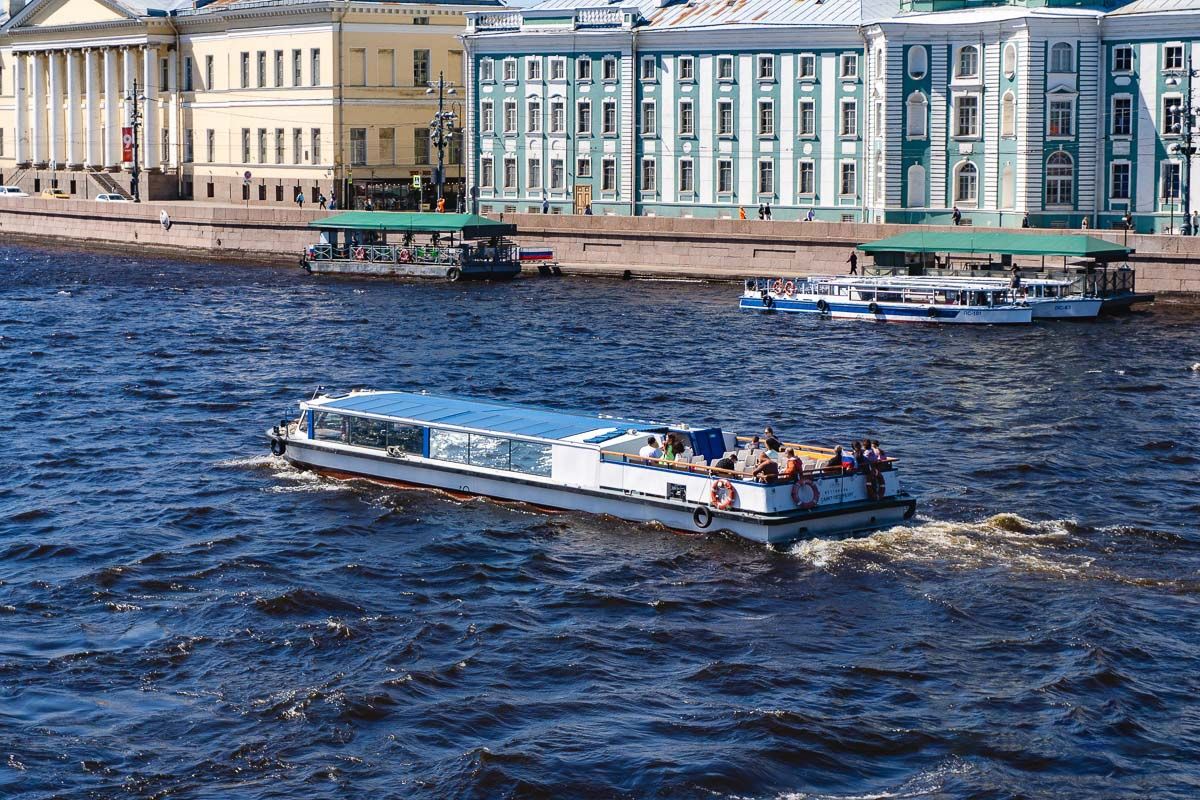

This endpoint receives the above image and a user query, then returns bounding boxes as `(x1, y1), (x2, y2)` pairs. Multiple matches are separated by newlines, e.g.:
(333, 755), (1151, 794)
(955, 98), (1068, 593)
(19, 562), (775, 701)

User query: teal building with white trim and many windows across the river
(463, 0), (1200, 231)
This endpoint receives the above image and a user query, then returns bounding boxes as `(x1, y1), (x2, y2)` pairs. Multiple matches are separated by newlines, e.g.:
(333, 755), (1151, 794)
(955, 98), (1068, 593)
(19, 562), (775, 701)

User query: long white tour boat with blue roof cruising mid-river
(268, 391), (916, 543)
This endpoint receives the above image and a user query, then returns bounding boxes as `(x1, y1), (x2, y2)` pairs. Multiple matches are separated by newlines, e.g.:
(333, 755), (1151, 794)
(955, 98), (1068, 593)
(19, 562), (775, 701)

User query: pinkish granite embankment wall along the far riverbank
(0, 198), (1200, 301)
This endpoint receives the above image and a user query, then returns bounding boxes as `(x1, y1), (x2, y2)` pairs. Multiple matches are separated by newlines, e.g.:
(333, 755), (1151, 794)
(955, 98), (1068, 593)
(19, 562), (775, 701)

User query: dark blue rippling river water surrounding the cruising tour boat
(0, 247), (1200, 800)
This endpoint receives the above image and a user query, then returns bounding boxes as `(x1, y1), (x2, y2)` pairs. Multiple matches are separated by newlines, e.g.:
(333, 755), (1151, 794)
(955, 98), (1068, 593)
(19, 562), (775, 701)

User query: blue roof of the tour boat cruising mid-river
(319, 392), (662, 441)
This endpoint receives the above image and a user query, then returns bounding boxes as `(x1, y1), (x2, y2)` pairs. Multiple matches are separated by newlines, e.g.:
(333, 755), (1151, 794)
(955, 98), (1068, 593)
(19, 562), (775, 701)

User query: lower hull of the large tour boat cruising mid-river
(274, 439), (916, 545)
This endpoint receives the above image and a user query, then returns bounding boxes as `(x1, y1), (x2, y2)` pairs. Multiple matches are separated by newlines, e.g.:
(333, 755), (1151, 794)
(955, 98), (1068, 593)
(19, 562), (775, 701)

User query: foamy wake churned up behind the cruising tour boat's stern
(787, 513), (1200, 594)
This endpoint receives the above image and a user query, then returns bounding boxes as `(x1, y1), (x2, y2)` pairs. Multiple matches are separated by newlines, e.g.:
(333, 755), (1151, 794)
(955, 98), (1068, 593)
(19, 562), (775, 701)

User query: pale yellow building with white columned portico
(0, 0), (502, 207)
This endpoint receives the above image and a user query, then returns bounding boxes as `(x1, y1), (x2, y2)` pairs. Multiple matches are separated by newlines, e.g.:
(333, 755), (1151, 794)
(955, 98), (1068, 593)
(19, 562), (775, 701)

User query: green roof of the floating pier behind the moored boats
(858, 230), (1133, 259)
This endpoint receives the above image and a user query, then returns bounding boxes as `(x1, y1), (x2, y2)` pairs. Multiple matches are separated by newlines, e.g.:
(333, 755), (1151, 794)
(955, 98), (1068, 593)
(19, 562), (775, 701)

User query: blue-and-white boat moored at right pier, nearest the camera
(739, 276), (1033, 325)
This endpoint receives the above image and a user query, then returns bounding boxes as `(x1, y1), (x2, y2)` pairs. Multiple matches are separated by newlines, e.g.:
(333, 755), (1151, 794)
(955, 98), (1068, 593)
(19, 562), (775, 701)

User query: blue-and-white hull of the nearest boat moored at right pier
(740, 295), (1033, 325)
